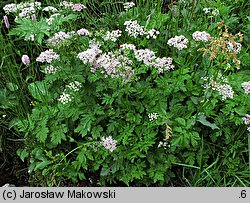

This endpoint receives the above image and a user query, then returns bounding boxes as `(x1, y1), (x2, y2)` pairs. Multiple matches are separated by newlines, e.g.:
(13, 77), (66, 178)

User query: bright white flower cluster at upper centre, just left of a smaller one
(124, 20), (146, 38)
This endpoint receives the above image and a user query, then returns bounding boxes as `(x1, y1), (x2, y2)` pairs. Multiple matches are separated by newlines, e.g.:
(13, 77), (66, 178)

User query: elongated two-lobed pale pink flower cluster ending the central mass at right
(134, 49), (174, 73)
